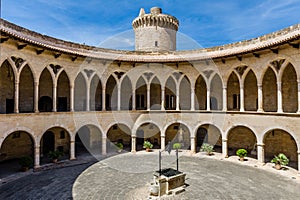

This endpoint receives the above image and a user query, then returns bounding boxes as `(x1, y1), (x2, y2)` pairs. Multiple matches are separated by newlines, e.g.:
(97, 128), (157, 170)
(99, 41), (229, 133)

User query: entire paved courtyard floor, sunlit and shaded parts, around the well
(0, 152), (300, 200)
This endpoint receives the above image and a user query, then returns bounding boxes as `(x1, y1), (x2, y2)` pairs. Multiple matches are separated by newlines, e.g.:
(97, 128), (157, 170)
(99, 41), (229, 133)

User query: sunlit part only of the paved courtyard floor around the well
(72, 152), (300, 200)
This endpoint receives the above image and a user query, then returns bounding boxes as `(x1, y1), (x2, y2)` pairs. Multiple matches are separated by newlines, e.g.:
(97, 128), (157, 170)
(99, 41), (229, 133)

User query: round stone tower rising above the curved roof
(132, 7), (179, 51)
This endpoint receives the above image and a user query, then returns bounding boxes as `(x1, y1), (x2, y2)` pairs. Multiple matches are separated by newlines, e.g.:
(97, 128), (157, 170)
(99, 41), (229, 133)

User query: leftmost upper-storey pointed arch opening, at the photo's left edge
(0, 60), (15, 114)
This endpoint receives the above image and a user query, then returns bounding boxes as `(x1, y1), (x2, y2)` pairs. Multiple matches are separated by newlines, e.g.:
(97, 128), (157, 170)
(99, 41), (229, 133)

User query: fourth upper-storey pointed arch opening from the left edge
(57, 71), (70, 112)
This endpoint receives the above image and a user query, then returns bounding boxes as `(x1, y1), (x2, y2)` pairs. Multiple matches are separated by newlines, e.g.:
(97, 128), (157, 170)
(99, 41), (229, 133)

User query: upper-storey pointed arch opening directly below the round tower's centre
(150, 77), (161, 110)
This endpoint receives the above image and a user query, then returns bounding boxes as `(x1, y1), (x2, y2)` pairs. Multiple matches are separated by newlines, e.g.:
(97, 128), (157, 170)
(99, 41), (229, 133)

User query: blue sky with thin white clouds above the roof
(1, 0), (300, 49)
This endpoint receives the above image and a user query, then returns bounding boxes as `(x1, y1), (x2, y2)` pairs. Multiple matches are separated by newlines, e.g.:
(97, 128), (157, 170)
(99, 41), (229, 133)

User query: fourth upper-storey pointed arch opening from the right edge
(227, 72), (240, 110)
